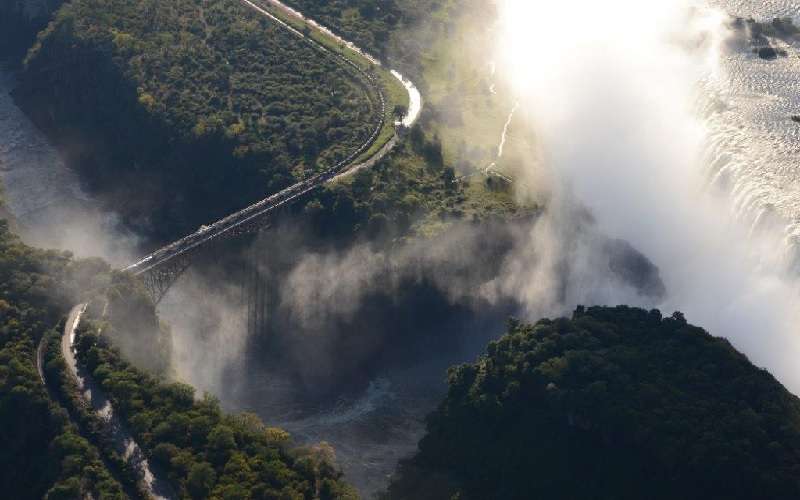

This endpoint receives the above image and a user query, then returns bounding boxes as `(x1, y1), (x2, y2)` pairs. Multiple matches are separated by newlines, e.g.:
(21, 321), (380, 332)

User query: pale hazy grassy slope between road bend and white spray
(412, 0), (536, 180)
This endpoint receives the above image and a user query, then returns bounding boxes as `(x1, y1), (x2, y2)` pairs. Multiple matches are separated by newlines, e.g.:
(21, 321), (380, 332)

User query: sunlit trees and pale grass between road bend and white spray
(288, 0), (536, 240)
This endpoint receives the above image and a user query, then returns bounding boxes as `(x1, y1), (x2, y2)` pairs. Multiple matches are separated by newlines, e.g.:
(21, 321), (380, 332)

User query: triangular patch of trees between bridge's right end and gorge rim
(304, 127), (536, 240)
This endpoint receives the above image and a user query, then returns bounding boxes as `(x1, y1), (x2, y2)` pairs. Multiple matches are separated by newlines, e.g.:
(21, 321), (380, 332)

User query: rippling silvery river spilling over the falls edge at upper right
(704, 1), (800, 273)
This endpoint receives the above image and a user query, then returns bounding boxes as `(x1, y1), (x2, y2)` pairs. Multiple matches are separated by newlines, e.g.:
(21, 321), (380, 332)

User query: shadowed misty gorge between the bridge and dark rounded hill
(162, 211), (664, 495)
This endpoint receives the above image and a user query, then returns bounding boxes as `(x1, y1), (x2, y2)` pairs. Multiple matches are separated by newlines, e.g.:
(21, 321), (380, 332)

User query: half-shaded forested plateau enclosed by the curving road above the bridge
(17, 0), (377, 237)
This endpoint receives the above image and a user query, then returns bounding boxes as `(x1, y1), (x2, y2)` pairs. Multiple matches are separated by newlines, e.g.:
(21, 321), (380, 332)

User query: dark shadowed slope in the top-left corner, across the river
(0, 0), (63, 65)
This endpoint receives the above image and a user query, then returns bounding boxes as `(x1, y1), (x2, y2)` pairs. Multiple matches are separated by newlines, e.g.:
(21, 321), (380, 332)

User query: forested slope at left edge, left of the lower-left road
(0, 221), (125, 500)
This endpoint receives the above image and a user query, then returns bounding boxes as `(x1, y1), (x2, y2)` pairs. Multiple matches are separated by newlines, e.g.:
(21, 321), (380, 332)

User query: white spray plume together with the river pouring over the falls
(498, 0), (800, 390)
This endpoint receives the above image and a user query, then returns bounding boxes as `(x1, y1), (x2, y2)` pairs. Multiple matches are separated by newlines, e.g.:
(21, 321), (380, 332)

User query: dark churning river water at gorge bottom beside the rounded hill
(224, 365), (446, 499)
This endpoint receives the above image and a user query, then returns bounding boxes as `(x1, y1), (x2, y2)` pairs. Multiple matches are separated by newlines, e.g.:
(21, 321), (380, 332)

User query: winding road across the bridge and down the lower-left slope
(36, 0), (422, 500)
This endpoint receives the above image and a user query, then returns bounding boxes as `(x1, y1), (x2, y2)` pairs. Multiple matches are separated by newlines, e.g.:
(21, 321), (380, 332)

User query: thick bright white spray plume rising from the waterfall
(498, 0), (800, 391)
